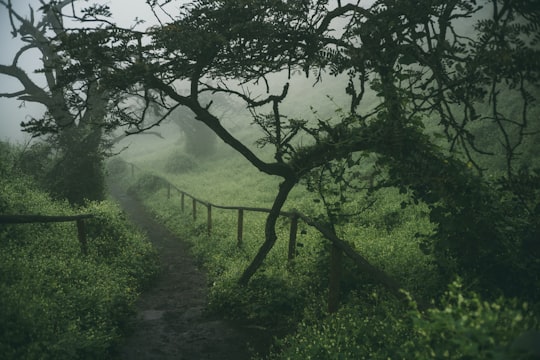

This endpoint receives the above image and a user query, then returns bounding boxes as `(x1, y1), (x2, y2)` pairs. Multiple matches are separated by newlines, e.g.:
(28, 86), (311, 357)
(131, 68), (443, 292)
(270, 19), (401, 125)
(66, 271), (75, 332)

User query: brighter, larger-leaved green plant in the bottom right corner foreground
(403, 282), (539, 359)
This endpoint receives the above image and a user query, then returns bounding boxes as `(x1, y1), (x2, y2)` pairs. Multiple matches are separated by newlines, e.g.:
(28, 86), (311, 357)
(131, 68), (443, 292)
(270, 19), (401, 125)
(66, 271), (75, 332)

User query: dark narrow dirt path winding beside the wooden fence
(109, 183), (271, 360)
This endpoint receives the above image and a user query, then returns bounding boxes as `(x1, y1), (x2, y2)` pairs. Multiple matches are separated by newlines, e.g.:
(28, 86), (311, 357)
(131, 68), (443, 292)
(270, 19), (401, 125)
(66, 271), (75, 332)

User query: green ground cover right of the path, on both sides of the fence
(118, 148), (538, 359)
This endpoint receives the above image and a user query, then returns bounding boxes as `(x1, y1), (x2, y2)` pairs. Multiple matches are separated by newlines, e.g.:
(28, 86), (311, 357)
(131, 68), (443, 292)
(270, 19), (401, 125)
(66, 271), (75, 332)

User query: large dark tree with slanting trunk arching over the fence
(64, 0), (540, 300)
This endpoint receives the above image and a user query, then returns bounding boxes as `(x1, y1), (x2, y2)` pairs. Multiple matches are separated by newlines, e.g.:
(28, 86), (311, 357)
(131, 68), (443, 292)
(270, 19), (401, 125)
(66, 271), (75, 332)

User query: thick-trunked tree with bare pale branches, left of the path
(0, 0), (117, 204)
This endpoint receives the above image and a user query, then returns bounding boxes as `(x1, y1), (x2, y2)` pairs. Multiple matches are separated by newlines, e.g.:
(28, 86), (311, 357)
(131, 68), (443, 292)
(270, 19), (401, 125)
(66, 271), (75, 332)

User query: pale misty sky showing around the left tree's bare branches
(0, 0), (177, 141)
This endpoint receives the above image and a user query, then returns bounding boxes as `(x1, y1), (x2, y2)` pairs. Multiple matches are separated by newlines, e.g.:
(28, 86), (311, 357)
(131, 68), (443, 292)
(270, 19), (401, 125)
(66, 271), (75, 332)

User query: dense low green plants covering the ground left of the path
(0, 143), (158, 359)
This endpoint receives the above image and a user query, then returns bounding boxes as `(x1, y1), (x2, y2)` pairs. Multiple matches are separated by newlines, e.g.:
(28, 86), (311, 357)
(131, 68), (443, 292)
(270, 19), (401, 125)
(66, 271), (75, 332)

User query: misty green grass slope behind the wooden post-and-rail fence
(119, 141), (436, 304)
